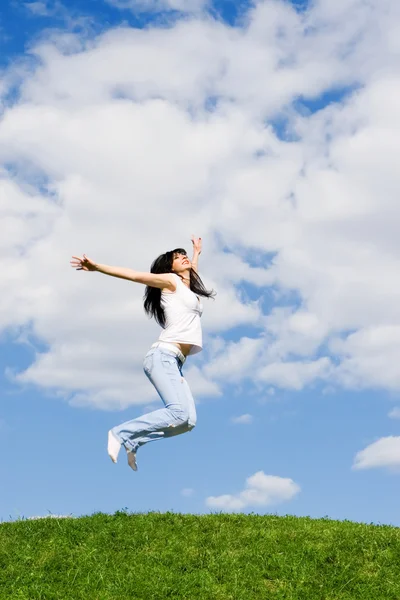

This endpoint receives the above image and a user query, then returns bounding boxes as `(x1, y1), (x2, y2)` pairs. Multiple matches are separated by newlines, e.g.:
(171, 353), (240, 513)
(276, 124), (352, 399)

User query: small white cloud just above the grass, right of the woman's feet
(206, 471), (300, 511)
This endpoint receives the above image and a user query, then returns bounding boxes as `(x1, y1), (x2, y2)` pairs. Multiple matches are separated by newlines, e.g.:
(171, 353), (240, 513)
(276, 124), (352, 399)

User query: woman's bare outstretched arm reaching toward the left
(71, 254), (176, 291)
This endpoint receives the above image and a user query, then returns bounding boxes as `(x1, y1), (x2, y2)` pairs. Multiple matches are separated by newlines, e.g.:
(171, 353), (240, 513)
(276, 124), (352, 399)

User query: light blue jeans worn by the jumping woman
(112, 348), (196, 452)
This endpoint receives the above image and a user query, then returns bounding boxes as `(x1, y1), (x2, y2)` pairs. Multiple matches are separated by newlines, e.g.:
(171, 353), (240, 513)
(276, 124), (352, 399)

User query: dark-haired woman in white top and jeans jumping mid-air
(71, 237), (215, 471)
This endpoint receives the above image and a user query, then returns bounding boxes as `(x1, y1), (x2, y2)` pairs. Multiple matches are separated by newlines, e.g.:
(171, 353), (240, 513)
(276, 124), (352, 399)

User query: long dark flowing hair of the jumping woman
(143, 248), (215, 328)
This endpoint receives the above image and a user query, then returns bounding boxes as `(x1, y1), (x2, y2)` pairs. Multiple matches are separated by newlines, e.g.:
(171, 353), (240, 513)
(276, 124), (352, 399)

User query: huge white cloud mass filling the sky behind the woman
(0, 0), (400, 408)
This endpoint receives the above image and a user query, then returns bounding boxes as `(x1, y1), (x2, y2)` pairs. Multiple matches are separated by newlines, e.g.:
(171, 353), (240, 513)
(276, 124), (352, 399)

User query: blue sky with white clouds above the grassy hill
(0, 0), (400, 525)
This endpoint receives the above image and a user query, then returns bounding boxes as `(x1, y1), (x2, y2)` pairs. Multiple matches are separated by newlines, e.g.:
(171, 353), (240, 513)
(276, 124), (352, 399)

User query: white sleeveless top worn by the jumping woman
(158, 273), (203, 354)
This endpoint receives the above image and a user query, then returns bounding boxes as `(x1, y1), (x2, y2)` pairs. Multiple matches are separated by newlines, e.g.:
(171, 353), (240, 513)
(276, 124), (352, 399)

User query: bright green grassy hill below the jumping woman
(0, 512), (400, 600)
